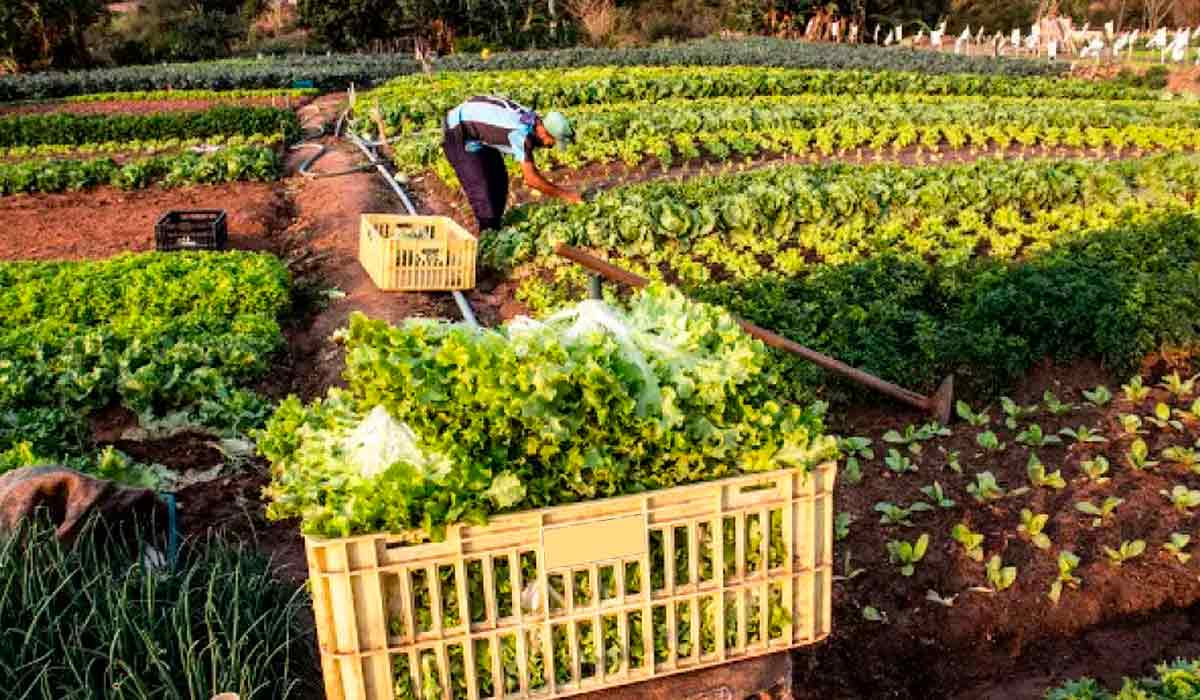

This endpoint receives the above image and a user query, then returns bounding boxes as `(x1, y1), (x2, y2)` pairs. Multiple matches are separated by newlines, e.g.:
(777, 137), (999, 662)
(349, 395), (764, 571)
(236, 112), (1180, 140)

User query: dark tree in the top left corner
(0, 0), (106, 70)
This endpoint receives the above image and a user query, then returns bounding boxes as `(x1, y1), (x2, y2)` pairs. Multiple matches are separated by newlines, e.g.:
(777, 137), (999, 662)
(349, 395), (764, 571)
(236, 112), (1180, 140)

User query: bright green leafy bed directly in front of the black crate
(0, 252), (289, 480)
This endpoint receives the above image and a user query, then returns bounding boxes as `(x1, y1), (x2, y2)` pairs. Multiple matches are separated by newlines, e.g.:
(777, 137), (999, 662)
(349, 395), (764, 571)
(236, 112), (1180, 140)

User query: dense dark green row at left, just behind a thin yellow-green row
(0, 106), (300, 148)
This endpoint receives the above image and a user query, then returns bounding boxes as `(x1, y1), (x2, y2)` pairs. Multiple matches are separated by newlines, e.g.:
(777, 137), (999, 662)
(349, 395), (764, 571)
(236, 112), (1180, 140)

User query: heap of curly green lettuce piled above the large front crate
(259, 285), (836, 542)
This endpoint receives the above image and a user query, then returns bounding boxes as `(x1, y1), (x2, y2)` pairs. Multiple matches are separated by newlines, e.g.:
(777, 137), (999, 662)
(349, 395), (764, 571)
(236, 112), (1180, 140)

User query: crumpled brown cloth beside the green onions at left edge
(0, 466), (166, 542)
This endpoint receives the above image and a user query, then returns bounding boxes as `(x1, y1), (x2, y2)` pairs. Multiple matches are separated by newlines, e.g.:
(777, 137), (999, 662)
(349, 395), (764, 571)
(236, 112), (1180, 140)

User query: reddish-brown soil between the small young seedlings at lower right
(797, 364), (1200, 700)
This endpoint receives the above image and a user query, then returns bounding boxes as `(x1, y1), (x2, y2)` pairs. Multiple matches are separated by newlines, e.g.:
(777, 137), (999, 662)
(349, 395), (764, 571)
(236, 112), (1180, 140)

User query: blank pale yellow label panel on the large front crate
(541, 514), (646, 569)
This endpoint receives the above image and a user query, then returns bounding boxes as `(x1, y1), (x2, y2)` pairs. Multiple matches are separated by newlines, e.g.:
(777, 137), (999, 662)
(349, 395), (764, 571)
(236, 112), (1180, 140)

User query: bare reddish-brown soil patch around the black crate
(0, 183), (288, 261)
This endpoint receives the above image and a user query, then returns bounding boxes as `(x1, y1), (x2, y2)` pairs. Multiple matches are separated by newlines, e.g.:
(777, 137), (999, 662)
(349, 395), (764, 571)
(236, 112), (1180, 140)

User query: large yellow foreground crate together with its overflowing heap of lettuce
(260, 287), (834, 700)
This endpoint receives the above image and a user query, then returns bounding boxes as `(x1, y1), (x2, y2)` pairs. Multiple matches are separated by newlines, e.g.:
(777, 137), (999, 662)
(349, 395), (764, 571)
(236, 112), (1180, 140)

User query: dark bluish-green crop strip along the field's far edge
(0, 38), (1066, 102)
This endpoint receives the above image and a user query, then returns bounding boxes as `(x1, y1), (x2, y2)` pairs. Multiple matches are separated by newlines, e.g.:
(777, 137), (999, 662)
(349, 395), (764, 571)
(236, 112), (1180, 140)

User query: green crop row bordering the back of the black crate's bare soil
(0, 145), (282, 196)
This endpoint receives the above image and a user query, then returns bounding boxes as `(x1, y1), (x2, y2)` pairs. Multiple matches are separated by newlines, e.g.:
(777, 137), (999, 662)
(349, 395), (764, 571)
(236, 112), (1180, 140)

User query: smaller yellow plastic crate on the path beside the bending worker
(359, 214), (476, 292)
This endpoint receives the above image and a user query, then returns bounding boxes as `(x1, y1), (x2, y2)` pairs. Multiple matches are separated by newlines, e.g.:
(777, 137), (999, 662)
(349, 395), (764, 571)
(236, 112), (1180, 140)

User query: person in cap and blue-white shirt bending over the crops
(442, 96), (583, 232)
